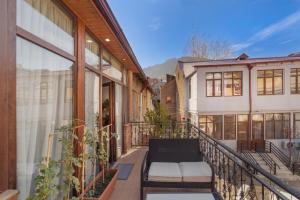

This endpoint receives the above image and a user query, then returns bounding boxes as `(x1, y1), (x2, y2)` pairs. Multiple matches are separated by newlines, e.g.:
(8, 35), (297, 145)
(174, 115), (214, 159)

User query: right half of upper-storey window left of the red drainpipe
(223, 72), (242, 96)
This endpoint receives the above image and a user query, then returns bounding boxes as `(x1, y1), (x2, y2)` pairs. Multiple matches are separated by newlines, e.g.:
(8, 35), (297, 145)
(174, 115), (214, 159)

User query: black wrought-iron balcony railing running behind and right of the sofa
(132, 123), (300, 200)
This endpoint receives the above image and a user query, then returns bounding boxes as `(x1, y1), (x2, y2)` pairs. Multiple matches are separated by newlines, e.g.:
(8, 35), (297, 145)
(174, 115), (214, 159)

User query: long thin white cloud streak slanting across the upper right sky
(231, 10), (300, 51)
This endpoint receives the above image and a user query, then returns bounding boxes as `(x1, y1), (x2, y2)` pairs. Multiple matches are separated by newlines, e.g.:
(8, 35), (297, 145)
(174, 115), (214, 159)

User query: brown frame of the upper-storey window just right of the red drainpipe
(256, 69), (284, 96)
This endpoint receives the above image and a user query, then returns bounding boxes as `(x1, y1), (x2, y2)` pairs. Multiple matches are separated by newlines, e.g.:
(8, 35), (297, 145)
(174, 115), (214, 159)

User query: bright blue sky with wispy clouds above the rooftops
(108, 0), (300, 67)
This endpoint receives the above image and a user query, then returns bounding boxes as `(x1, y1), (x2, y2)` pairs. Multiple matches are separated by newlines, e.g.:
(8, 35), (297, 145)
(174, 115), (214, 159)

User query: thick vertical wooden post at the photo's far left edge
(0, 0), (16, 191)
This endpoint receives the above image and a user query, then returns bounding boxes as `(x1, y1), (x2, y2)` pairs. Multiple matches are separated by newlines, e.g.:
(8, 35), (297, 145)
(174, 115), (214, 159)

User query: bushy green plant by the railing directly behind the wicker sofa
(144, 104), (169, 137)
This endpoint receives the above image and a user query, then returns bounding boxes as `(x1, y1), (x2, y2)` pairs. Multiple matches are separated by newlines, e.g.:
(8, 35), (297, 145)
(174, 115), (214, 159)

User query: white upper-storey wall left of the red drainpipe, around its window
(197, 66), (249, 114)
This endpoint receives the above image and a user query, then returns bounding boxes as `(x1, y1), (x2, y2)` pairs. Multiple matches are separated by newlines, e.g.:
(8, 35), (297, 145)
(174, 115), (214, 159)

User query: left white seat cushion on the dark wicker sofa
(148, 162), (182, 182)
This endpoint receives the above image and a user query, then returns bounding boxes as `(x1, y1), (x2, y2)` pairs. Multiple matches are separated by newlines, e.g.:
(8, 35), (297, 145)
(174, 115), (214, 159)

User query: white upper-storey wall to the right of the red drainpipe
(252, 62), (300, 112)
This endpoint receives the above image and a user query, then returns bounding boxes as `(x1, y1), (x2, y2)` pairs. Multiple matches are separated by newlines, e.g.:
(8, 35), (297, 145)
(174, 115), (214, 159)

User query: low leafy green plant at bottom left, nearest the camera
(27, 160), (59, 200)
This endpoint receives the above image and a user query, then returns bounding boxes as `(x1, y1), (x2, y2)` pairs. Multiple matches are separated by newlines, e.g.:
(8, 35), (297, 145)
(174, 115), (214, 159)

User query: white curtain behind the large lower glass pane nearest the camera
(17, 38), (73, 199)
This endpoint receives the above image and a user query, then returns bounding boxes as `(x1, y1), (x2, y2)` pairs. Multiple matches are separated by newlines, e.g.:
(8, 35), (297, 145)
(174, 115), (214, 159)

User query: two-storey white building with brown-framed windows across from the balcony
(176, 54), (300, 148)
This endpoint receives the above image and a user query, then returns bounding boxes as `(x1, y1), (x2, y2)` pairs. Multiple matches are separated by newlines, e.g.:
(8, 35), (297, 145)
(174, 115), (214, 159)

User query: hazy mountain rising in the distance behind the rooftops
(143, 58), (178, 79)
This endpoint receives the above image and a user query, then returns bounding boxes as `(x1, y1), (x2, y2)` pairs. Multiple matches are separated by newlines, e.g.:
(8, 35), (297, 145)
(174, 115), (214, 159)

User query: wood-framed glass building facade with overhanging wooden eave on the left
(0, 0), (152, 199)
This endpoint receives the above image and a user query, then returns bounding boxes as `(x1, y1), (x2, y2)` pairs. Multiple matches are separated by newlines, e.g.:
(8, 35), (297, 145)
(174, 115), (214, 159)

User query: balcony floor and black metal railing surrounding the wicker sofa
(111, 123), (300, 200)
